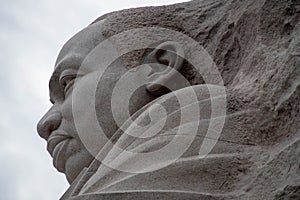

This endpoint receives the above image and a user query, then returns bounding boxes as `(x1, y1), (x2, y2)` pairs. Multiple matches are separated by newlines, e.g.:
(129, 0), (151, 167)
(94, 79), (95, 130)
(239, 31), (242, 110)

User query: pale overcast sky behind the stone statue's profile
(0, 0), (188, 200)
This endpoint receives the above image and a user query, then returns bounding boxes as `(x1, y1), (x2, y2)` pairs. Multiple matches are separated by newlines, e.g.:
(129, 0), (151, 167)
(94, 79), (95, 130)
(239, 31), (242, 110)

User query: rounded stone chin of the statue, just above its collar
(65, 151), (94, 184)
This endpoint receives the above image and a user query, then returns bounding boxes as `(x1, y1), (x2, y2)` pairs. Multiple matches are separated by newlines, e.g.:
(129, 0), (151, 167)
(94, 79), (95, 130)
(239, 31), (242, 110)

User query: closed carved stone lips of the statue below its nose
(47, 131), (73, 172)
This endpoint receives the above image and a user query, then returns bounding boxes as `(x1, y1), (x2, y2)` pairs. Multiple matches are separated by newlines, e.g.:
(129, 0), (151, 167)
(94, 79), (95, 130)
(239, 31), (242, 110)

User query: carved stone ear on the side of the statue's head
(145, 41), (185, 96)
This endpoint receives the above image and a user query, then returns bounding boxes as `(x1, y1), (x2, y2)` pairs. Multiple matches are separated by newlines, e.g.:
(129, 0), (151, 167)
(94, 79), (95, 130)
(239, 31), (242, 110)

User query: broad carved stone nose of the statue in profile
(37, 111), (62, 140)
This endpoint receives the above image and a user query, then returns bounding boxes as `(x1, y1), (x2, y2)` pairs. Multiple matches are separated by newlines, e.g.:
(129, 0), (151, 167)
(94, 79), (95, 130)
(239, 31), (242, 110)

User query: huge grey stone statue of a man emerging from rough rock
(37, 0), (300, 200)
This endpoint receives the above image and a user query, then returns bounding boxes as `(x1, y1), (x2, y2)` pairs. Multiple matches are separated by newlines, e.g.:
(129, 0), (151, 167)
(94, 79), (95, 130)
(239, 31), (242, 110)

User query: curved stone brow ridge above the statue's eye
(49, 55), (83, 104)
